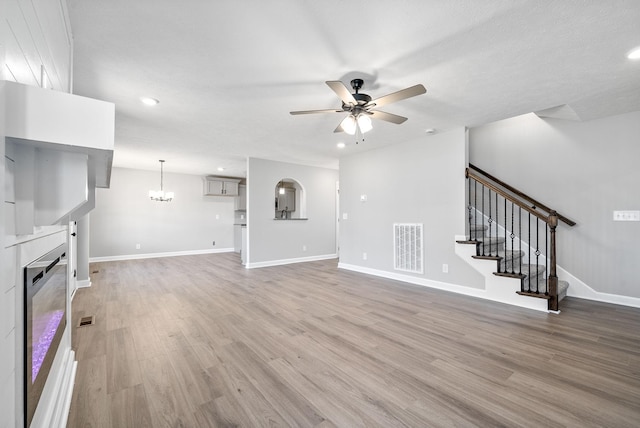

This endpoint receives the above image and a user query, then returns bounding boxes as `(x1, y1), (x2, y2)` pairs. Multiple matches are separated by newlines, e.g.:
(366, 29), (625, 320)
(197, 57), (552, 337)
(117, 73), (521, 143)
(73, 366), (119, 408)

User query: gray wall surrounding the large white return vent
(340, 128), (484, 288)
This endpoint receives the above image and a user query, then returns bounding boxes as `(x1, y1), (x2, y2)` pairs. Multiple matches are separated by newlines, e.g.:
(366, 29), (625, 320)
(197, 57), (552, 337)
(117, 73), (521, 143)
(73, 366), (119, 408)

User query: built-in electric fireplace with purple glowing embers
(24, 244), (67, 426)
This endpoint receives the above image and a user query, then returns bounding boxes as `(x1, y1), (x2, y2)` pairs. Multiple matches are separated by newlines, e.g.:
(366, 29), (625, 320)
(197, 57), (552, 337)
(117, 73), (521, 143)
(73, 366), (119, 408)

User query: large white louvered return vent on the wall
(393, 223), (423, 273)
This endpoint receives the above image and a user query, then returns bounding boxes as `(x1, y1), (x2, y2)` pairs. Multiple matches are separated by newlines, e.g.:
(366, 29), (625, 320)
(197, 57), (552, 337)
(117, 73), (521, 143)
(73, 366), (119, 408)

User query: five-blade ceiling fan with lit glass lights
(290, 79), (427, 135)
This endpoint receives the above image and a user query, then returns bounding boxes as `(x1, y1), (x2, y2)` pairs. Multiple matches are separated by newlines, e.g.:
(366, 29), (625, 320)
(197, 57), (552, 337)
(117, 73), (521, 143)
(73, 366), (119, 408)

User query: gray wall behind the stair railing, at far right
(469, 108), (640, 298)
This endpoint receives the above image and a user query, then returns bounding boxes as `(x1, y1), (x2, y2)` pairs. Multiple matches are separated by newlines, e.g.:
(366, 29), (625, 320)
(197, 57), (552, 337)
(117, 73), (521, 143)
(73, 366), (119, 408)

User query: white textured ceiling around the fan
(67, 0), (640, 176)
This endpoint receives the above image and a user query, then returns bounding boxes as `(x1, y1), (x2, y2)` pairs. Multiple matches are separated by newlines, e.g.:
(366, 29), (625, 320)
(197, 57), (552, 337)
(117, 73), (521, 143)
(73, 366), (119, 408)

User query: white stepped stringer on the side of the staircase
(455, 235), (549, 312)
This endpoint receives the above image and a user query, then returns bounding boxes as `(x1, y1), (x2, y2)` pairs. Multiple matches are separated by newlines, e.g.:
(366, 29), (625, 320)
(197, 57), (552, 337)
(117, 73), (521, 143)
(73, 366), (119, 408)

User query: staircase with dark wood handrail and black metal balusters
(456, 165), (575, 312)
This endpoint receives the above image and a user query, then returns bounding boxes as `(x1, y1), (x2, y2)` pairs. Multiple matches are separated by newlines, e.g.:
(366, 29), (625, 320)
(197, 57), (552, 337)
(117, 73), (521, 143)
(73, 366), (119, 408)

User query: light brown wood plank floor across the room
(68, 253), (640, 428)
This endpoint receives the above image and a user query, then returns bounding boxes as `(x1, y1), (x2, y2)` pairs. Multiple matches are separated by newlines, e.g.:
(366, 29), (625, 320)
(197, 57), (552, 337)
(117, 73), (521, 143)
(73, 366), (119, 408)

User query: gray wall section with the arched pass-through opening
(247, 158), (338, 267)
